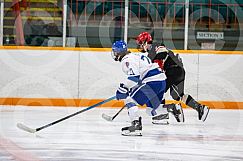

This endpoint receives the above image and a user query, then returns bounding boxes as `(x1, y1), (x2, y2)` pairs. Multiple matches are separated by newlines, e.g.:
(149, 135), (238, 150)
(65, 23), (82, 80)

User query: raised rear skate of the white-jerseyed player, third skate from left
(168, 104), (185, 122)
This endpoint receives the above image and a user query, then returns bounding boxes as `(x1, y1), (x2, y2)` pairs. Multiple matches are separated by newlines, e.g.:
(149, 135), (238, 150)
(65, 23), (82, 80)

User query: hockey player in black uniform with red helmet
(136, 32), (209, 121)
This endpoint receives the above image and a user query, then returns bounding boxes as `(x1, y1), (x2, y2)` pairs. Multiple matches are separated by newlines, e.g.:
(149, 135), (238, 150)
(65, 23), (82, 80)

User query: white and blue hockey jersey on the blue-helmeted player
(121, 53), (166, 89)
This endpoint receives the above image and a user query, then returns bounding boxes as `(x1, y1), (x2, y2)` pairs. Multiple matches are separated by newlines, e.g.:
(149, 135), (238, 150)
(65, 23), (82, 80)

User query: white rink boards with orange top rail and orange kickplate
(0, 47), (243, 109)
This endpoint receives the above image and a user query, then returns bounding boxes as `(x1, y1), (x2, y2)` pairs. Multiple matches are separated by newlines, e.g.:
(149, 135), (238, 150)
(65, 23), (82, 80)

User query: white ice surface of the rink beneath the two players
(0, 106), (243, 161)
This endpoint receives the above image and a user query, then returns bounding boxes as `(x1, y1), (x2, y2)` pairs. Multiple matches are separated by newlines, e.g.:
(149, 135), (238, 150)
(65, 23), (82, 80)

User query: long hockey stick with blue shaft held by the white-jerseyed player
(17, 96), (116, 133)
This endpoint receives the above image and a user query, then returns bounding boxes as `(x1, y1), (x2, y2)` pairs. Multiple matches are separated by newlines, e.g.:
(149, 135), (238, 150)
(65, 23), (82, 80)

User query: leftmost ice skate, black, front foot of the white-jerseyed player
(122, 117), (142, 136)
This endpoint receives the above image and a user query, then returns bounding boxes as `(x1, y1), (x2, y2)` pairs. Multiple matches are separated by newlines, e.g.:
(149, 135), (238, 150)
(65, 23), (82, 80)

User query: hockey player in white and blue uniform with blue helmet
(112, 40), (184, 136)
